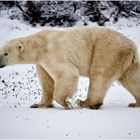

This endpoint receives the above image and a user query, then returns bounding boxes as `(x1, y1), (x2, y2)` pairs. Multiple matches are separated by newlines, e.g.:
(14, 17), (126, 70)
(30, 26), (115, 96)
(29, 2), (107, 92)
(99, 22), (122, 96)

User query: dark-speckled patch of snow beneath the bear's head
(0, 65), (41, 108)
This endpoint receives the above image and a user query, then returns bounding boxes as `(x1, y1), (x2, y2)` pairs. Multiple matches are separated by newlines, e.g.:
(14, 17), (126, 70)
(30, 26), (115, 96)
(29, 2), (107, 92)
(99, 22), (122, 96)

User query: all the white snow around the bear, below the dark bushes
(0, 18), (140, 139)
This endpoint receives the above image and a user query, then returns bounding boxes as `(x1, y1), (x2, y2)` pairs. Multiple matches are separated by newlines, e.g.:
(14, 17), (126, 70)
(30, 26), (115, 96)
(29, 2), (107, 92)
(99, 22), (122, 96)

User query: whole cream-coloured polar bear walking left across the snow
(0, 26), (140, 109)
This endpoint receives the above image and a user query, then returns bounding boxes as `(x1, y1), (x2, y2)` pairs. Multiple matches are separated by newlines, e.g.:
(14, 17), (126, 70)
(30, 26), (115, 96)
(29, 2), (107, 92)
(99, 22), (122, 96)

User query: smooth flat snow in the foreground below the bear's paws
(0, 106), (140, 139)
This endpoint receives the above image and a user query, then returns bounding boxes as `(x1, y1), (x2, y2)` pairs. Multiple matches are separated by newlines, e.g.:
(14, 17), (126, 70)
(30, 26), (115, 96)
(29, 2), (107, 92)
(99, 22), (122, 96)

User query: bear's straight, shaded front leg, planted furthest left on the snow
(31, 64), (54, 108)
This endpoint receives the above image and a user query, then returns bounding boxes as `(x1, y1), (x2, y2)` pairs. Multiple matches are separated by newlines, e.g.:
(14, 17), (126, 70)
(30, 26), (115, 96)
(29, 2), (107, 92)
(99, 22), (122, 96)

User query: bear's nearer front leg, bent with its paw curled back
(53, 67), (79, 109)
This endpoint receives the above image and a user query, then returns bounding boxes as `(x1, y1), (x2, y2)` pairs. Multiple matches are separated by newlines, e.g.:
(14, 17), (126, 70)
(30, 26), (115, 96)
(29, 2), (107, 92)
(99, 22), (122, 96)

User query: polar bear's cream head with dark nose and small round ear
(0, 38), (40, 68)
